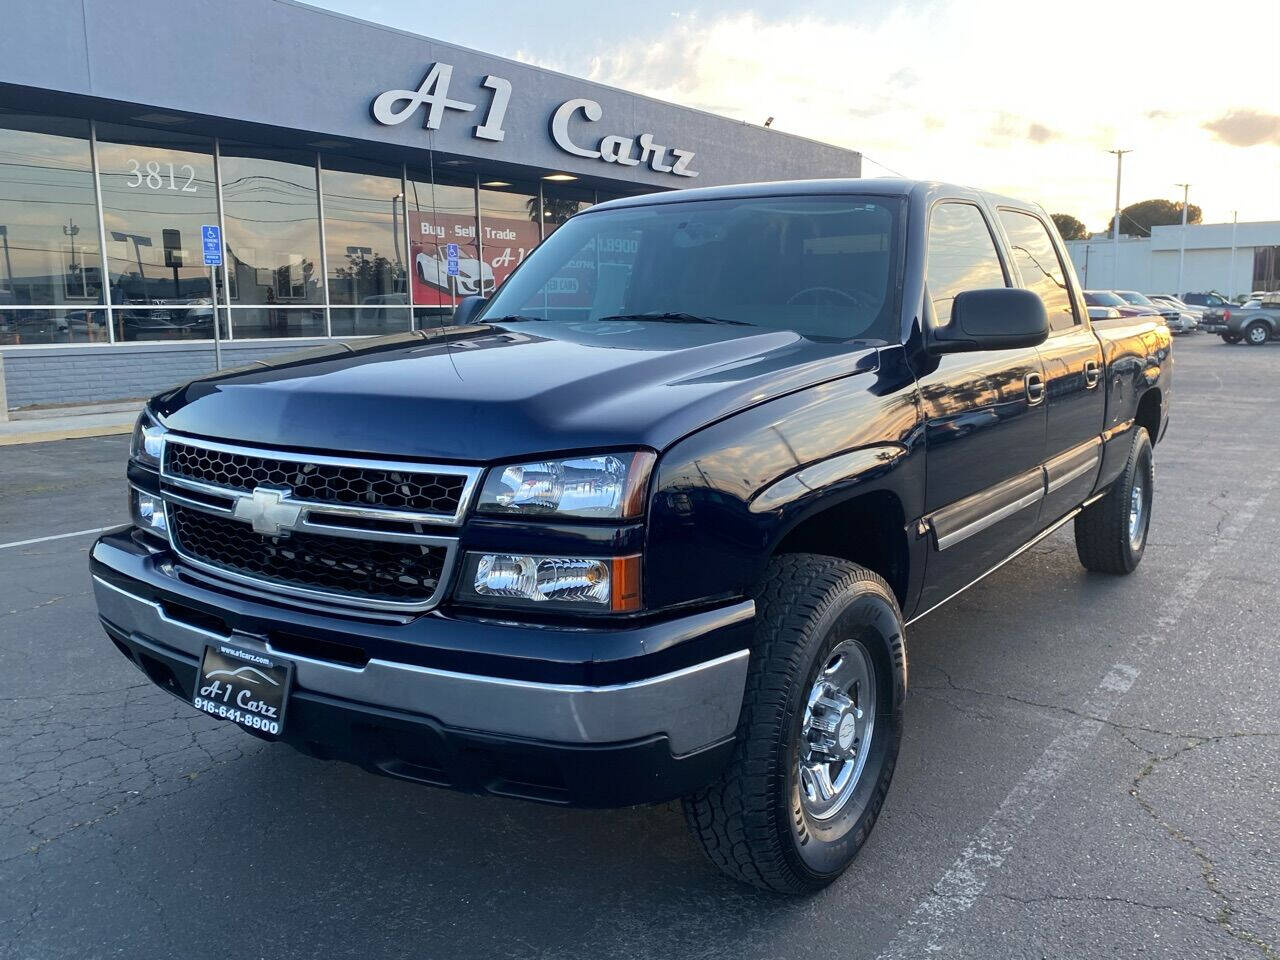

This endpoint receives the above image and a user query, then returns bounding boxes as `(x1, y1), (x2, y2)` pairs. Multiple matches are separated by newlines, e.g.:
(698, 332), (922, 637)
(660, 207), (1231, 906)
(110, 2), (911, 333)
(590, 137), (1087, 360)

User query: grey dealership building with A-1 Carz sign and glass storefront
(0, 0), (861, 410)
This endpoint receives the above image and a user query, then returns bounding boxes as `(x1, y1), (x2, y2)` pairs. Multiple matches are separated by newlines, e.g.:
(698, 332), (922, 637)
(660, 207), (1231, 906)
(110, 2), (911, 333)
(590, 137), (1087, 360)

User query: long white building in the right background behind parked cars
(1066, 220), (1280, 297)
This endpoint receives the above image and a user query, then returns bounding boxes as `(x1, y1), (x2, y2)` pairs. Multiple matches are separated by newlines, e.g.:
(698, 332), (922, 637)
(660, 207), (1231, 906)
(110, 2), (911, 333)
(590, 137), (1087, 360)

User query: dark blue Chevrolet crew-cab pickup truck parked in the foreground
(91, 179), (1172, 893)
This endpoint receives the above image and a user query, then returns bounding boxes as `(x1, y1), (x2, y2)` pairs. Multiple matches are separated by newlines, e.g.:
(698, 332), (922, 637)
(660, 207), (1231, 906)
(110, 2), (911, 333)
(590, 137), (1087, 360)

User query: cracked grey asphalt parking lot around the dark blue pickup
(0, 335), (1280, 959)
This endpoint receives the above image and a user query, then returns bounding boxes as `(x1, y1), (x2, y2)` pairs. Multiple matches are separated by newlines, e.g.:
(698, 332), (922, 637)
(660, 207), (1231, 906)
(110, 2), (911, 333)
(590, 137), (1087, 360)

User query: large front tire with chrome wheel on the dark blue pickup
(684, 554), (906, 893)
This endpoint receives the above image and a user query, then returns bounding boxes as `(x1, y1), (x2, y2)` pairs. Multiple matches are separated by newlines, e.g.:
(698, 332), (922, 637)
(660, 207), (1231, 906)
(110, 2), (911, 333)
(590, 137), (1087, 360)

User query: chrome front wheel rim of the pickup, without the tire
(796, 640), (876, 820)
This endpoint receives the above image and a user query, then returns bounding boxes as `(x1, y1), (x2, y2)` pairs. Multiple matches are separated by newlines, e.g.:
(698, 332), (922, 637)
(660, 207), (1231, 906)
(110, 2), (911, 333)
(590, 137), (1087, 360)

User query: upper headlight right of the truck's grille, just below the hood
(476, 451), (654, 518)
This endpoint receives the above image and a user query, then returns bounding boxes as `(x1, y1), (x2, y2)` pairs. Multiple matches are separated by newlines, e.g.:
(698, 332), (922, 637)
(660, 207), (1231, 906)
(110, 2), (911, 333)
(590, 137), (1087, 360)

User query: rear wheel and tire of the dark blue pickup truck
(1075, 426), (1156, 575)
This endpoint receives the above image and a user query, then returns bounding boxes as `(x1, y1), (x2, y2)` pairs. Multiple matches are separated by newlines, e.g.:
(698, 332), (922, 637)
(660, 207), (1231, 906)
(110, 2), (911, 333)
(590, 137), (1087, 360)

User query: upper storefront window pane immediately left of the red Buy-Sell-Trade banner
(320, 159), (408, 305)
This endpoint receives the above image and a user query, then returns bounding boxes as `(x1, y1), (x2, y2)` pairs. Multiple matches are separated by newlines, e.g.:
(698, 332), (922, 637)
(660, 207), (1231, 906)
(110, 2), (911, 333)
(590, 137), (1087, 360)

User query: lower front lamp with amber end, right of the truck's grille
(461, 553), (640, 613)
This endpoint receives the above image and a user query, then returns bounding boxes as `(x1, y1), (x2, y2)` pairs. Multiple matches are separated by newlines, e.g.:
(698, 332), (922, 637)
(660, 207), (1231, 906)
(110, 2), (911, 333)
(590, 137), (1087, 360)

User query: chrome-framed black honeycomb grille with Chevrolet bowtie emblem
(160, 434), (480, 612)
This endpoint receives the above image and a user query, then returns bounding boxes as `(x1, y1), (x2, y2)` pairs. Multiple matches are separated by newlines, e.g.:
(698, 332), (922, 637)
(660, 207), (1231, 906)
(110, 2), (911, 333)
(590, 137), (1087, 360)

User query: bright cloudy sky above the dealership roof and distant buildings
(312, 0), (1280, 230)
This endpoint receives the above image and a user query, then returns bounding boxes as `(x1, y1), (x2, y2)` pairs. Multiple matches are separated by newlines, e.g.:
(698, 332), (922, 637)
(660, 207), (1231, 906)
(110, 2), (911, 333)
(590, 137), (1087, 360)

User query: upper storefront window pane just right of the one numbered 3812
(221, 142), (324, 305)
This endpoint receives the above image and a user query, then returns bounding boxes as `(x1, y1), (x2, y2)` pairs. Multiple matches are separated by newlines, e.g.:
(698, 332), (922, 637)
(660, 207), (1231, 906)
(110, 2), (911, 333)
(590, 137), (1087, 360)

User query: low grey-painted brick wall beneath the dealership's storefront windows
(0, 340), (333, 410)
